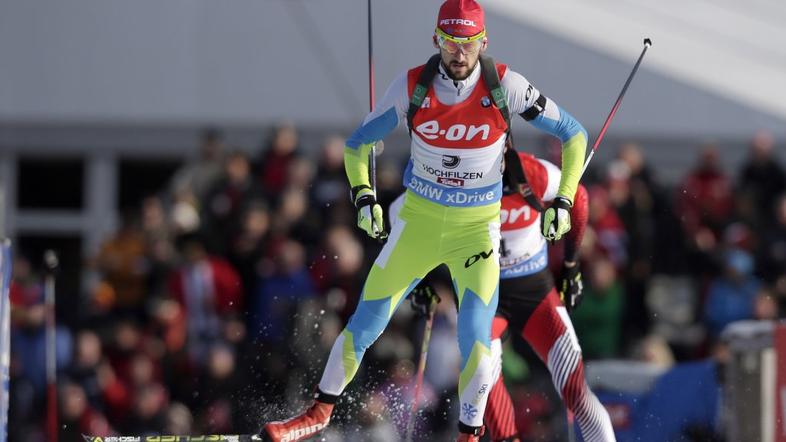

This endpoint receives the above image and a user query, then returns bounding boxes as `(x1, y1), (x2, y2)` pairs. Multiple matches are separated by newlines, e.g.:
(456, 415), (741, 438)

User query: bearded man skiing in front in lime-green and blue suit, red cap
(262, 0), (587, 442)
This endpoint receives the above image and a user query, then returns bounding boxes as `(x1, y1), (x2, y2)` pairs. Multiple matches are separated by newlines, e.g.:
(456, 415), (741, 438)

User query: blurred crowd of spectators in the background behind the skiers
(9, 125), (786, 441)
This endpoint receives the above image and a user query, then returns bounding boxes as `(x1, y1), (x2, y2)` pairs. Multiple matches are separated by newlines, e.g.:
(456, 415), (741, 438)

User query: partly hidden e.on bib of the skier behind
(499, 152), (560, 278)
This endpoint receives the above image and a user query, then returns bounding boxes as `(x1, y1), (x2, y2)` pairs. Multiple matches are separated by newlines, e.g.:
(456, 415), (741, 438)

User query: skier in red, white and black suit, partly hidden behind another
(402, 153), (615, 442)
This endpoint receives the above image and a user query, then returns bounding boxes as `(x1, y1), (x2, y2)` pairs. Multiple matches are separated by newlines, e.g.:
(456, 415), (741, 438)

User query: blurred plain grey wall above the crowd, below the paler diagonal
(0, 0), (786, 137)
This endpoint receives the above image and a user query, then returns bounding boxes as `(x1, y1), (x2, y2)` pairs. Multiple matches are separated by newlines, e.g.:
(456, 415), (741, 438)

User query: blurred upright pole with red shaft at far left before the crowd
(44, 250), (58, 442)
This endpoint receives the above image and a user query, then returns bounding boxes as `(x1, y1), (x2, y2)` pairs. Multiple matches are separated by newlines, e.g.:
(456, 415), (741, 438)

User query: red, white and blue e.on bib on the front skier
(404, 64), (507, 207)
